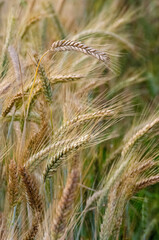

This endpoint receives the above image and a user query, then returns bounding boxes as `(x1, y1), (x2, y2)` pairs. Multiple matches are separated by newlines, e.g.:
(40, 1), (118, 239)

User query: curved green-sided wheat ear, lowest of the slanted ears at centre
(44, 135), (90, 181)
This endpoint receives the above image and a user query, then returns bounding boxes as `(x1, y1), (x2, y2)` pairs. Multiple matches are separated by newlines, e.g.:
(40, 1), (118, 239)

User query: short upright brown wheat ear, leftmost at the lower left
(8, 160), (19, 207)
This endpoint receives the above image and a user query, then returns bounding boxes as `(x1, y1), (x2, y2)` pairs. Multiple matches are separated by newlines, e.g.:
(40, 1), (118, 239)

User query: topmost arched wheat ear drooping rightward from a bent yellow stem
(50, 40), (109, 63)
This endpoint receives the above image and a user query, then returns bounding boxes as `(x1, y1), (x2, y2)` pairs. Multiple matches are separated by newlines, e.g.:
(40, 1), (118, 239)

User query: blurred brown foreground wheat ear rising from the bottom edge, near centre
(53, 169), (79, 240)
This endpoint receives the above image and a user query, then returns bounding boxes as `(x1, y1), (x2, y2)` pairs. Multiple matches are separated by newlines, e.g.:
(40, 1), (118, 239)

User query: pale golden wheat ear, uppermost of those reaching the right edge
(121, 118), (159, 156)
